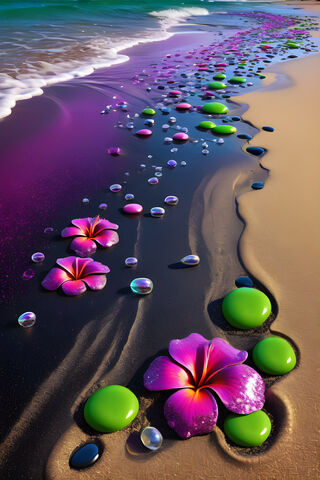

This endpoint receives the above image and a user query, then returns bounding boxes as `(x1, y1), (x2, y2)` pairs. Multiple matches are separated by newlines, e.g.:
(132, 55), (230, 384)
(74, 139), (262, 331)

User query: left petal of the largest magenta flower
(144, 356), (192, 390)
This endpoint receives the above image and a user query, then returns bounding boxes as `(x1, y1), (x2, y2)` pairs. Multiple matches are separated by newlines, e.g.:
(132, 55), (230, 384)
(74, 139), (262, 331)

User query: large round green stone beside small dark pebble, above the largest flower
(222, 287), (271, 330)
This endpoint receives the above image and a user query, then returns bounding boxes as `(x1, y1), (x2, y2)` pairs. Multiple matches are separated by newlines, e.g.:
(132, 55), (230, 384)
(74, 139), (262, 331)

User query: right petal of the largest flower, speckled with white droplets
(207, 365), (265, 414)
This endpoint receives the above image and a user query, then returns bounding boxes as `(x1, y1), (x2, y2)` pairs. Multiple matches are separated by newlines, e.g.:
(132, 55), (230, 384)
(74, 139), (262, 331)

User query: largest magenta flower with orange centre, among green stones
(144, 333), (265, 438)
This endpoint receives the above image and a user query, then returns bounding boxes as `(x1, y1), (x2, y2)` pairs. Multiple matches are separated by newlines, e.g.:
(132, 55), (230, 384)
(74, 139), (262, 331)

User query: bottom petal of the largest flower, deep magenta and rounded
(164, 388), (218, 438)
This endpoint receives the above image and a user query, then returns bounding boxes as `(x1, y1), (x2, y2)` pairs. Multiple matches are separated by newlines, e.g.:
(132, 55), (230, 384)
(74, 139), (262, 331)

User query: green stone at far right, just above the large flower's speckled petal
(252, 337), (297, 375)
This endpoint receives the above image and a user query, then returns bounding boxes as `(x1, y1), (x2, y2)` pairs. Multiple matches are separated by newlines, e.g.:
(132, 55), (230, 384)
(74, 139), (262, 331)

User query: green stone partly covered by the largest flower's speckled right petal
(223, 410), (271, 447)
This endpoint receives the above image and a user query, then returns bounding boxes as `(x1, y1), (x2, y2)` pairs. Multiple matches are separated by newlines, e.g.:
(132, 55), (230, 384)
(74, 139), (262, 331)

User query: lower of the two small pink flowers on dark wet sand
(41, 257), (110, 295)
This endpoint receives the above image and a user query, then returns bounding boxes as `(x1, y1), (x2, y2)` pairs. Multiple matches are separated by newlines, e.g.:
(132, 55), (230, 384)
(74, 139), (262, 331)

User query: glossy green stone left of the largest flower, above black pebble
(84, 385), (139, 432)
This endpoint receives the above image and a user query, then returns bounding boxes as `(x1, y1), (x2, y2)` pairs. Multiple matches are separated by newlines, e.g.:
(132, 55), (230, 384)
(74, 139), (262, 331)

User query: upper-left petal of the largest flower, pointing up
(169, 333), (210, 380)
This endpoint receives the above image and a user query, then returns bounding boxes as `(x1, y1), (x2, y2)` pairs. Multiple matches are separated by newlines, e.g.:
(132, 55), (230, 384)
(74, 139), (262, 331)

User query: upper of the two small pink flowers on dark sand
(61, 215), (119, 257)
